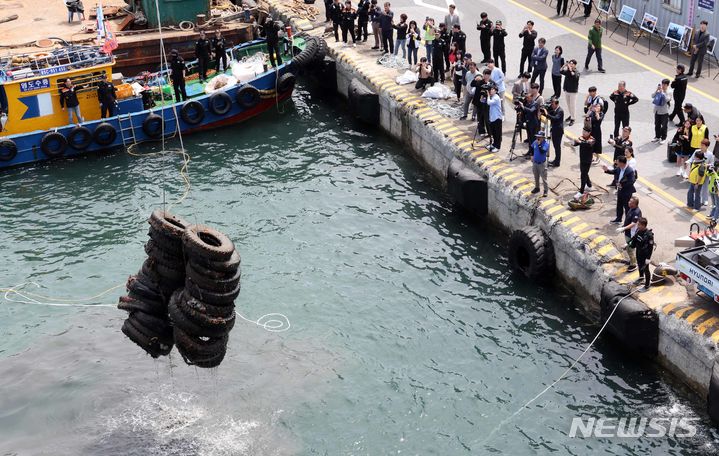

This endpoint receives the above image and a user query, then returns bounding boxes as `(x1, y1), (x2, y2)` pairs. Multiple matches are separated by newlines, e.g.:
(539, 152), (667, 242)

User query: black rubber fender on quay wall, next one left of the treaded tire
(447, 158), (489, 218)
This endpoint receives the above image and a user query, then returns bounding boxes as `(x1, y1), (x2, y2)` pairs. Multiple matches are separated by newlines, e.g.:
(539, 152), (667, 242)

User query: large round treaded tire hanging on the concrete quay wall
(509, 226), (554, 281)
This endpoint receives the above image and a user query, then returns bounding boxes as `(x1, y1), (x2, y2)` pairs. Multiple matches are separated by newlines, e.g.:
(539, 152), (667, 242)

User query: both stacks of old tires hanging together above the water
(117, 210), (241, 368)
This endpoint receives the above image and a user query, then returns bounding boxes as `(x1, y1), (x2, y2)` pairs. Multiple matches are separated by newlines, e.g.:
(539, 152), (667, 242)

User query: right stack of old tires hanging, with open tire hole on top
(168, 225), (241, 368)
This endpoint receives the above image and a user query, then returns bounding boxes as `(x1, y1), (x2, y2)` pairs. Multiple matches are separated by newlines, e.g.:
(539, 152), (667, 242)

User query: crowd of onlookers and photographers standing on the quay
(325, 0), (719, 290)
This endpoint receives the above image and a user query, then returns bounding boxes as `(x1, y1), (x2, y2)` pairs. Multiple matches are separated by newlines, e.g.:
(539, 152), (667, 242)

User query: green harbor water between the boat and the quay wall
(0, 89), (719, 456)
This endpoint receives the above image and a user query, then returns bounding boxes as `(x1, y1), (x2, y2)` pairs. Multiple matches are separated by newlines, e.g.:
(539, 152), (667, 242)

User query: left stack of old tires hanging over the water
(117, 210), (189, 358)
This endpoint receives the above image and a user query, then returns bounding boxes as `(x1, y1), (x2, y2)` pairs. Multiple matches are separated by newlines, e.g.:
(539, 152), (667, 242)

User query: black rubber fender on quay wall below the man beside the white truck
(600, 281), (659, 357)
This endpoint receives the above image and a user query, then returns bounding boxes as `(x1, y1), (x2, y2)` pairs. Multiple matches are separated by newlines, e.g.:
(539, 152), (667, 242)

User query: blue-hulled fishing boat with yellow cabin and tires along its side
(0, 37), (324, 168)
